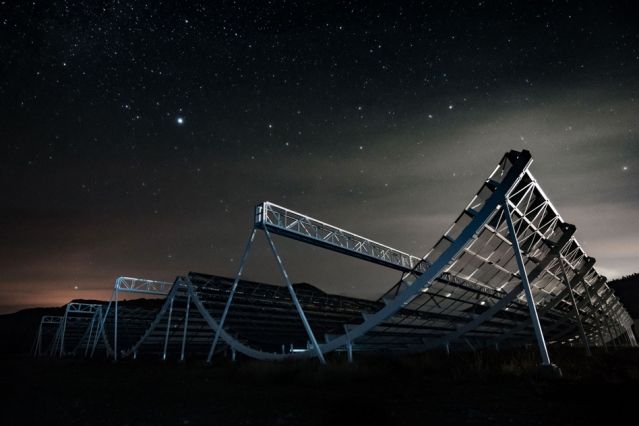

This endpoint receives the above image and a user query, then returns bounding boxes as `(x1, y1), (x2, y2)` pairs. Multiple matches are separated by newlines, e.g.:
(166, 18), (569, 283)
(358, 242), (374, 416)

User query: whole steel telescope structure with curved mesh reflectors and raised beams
(34, 151), (636, 365)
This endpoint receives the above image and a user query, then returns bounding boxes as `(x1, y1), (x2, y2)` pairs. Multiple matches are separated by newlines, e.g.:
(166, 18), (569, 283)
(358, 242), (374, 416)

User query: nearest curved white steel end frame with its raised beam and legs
(195, 151), (634, 365)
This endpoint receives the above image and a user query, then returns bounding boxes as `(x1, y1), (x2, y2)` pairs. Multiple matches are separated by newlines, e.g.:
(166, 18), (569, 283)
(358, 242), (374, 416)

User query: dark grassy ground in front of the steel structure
(0, 348), (639, 425)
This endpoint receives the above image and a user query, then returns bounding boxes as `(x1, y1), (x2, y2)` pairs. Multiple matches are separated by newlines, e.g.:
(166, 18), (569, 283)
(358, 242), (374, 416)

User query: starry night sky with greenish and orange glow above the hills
(0, 0), (639, 313)
